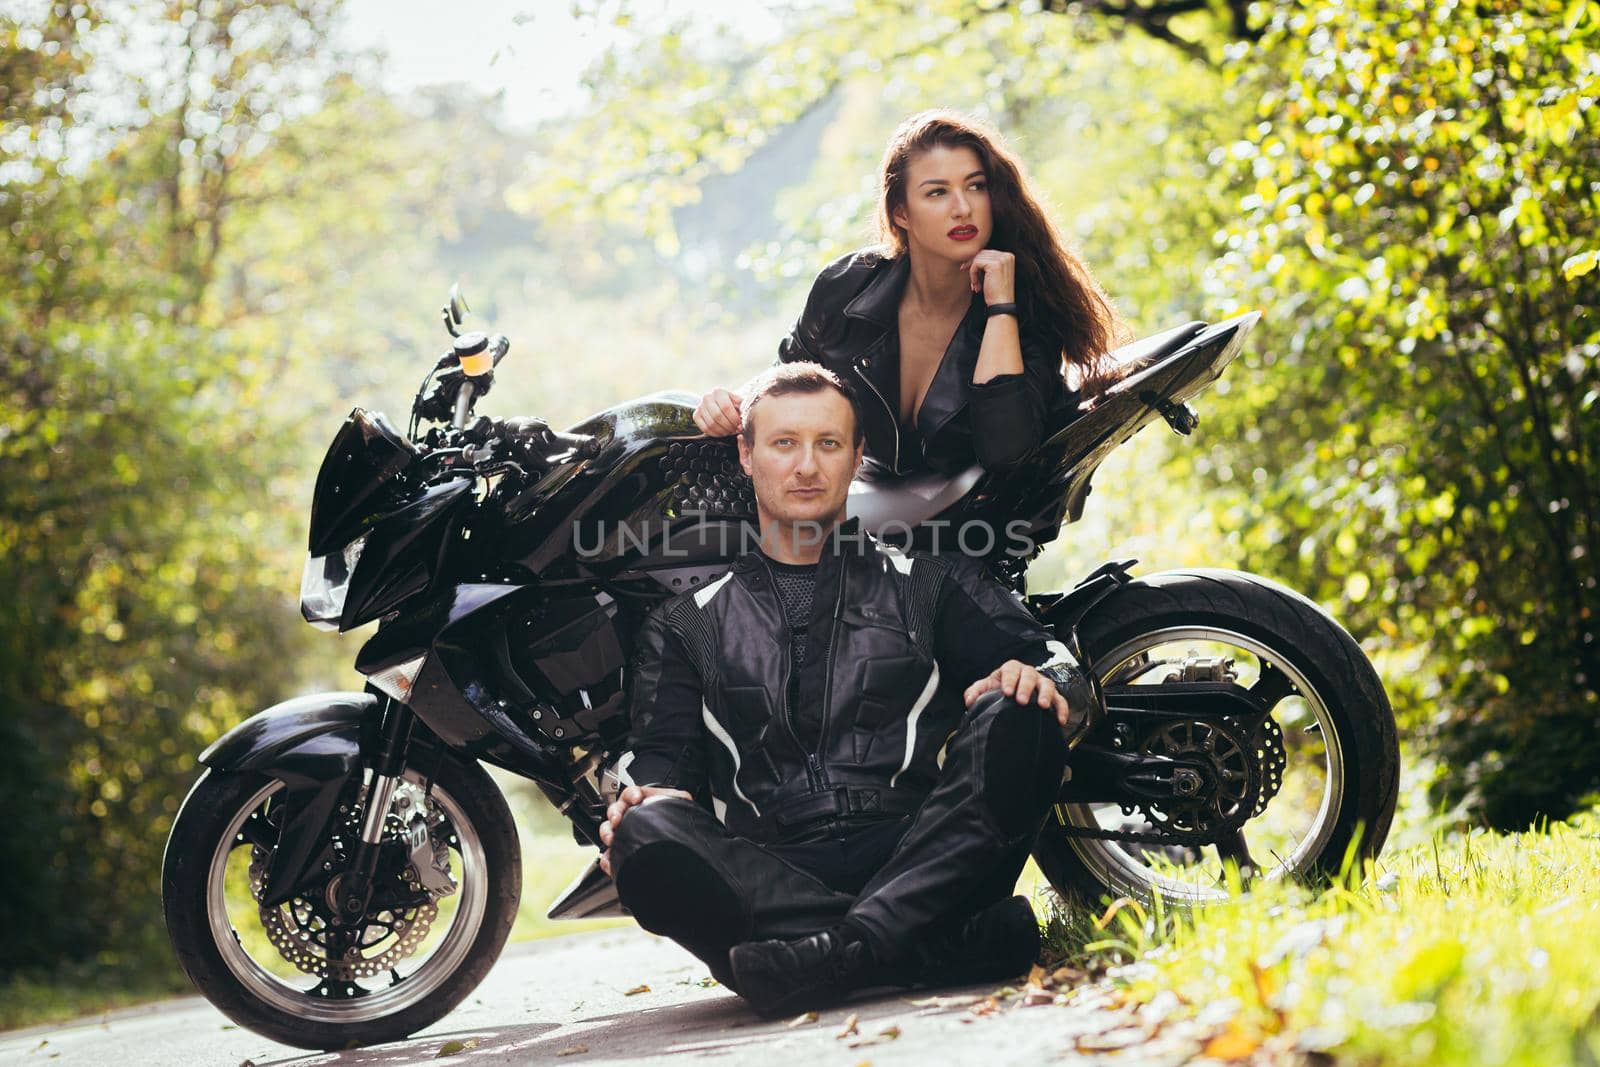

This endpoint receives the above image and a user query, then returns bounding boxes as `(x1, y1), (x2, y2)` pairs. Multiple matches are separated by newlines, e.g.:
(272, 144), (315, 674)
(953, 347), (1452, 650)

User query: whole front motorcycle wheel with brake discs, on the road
(162, 760), (522, 1049)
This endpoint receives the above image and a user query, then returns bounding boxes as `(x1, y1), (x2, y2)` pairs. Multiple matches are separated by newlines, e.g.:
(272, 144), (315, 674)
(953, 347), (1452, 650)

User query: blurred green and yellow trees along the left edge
(0, 3), (347, 976)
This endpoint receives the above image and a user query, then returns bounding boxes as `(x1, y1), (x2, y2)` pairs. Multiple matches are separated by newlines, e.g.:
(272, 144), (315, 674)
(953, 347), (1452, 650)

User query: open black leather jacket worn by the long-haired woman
(778, 250), (1075, 474)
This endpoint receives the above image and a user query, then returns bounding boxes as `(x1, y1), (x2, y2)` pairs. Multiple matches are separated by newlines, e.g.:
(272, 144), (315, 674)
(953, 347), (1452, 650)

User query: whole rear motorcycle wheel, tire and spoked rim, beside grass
(1034, 569), (1400, 905)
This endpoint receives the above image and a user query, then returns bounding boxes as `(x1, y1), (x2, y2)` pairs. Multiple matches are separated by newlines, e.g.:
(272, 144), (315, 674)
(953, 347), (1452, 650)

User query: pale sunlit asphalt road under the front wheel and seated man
(0, 928), (1222, 1067)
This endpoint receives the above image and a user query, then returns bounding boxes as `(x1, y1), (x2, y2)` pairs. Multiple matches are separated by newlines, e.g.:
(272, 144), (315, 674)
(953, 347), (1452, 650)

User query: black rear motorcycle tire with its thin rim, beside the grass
(1034, 569), (1400, 907)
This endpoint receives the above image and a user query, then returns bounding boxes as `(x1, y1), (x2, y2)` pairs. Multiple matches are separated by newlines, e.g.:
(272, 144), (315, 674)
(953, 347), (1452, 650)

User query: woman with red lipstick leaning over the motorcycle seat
(694, 110), (1120, 474)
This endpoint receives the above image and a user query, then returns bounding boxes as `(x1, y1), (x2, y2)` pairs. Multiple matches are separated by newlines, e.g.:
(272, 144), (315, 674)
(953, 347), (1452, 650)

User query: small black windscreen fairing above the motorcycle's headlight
(309, 408), (419, 555)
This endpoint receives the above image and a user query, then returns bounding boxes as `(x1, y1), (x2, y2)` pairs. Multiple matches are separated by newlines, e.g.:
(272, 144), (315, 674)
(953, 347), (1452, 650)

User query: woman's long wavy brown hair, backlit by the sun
(878, 110), (1126, 397)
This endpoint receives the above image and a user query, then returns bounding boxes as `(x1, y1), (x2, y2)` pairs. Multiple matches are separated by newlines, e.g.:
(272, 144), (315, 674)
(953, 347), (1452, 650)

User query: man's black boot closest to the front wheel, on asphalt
(728, 926), (880, 1019)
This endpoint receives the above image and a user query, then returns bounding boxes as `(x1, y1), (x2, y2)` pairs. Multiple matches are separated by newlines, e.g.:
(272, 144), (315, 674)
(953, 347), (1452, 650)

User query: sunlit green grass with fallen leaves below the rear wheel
(1048, 813), (1600, 1067)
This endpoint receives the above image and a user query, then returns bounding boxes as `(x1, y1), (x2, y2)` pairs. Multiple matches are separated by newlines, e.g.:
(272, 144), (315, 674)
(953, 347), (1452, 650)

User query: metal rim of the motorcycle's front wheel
(206, 773), (488, 1024)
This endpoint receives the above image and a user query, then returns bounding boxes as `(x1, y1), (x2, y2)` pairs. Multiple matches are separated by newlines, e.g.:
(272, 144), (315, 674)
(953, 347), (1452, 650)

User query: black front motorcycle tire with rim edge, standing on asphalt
(162, 760), (522, 1049)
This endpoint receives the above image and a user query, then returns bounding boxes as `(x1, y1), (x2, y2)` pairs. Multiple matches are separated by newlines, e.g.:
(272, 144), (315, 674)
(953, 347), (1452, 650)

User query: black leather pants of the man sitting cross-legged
(611, 691), (1067, 987)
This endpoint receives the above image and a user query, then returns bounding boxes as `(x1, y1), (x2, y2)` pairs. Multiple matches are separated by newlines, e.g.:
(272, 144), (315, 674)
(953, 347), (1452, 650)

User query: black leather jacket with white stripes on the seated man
(616, 523), (1083, 840)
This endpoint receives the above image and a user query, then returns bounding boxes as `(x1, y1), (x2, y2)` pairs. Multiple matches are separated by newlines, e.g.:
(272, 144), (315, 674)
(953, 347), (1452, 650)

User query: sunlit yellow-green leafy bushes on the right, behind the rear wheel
(1195, 2), (1600, 827)
